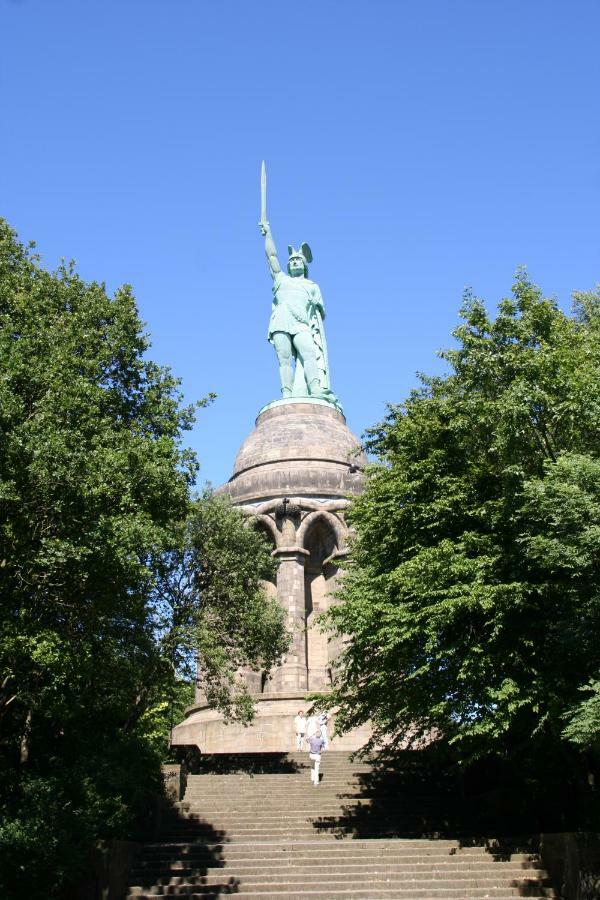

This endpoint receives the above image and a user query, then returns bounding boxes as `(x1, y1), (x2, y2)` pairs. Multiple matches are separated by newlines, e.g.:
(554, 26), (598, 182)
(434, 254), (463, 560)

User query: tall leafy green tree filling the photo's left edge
(0, 220), (283, 898)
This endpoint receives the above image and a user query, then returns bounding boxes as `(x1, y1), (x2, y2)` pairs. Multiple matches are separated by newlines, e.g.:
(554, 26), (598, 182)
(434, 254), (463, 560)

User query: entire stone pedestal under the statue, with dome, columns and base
(173, 398), (370, 753)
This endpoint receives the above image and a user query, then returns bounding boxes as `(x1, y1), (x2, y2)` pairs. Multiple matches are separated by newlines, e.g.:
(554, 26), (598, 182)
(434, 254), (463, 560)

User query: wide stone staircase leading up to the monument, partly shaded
(128, 752), (555, 900)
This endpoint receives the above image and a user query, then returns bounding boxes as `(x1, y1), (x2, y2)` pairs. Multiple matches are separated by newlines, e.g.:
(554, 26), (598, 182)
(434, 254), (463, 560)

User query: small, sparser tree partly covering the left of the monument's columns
(154, 492), (289, 724)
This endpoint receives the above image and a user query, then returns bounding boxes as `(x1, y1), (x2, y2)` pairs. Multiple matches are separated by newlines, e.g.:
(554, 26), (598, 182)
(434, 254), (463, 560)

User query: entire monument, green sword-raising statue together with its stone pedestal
(172, 163), (369, 753)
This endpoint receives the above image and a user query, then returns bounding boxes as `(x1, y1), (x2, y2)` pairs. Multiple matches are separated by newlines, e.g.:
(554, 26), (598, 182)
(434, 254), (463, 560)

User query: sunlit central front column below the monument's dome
(272, 546), (309, 692)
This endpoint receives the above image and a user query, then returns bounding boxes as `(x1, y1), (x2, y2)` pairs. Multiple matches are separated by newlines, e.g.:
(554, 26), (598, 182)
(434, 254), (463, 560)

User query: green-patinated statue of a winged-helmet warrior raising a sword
(259, 162), (341, 411)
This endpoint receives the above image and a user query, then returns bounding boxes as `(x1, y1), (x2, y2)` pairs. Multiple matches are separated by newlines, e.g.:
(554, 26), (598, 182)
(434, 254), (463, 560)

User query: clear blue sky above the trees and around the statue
(0, 0), (600, 485)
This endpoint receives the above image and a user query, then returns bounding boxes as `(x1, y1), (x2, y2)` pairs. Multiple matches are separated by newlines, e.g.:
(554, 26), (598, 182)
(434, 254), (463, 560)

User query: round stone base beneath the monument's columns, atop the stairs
(171, 692), (371, 753)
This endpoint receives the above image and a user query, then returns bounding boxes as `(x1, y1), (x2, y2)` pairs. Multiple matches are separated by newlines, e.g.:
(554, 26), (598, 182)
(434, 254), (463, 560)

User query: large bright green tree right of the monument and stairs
(328, 273), (600, 761)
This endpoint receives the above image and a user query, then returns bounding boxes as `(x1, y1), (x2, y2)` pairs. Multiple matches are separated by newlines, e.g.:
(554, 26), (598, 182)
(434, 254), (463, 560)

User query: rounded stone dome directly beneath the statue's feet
(217, 398), (366, 504)
